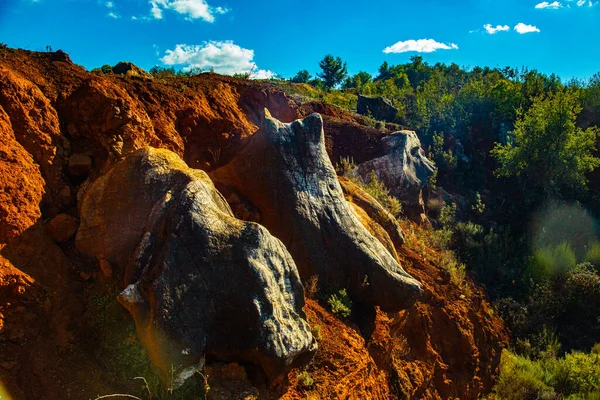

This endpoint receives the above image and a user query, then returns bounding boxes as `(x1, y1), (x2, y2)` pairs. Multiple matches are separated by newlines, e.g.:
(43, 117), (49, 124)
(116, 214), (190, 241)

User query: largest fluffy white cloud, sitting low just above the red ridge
(160, 40), (275, 79)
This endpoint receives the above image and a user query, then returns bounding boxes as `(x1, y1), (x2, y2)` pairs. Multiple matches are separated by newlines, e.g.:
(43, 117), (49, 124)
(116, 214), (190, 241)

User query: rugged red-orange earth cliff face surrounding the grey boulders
(0, 50), (506, 399)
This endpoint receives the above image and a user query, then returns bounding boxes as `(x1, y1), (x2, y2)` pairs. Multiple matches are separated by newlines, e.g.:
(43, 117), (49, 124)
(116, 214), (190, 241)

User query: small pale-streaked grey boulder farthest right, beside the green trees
(358, 131), (435, 222)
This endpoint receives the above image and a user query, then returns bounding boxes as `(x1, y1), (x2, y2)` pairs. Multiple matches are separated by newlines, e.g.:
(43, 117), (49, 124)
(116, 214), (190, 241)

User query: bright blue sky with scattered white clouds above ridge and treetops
(0, 0), (600, 80)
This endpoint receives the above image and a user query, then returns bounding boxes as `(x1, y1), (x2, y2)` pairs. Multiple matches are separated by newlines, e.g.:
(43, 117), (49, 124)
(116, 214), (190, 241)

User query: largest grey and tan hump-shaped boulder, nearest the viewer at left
(77, 148), (316, 385)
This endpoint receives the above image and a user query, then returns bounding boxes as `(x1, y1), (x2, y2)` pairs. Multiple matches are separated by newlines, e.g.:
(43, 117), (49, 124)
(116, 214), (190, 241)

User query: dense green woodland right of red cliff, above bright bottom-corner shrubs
(290, 56), (600, 368)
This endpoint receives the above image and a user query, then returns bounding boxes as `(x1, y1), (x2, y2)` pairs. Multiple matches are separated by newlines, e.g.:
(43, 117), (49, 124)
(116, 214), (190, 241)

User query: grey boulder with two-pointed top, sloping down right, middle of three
(211, 110), (421, 311)
